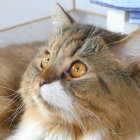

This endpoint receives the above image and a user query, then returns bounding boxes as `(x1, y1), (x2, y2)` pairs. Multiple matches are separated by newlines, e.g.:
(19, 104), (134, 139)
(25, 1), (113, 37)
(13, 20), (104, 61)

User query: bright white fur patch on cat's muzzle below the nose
(40, 81), (73, 112)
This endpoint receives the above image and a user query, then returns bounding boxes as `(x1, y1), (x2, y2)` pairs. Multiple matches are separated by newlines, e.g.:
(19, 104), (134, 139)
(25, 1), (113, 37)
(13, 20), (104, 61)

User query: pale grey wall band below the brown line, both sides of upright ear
(0, 12), (106, 47)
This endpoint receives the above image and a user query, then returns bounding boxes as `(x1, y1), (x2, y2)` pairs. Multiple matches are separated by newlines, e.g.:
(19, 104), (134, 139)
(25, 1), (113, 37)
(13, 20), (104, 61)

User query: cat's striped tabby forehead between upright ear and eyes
(48, 24), (97, 56)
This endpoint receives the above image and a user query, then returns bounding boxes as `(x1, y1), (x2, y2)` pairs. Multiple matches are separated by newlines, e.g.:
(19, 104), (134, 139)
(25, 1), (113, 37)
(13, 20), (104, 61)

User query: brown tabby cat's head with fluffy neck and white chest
(0, 5), (140, 140)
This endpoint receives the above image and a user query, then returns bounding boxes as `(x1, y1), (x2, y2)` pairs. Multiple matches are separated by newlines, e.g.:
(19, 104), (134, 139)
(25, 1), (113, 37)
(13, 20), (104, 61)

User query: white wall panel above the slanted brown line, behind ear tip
(0, 0), (73, 30)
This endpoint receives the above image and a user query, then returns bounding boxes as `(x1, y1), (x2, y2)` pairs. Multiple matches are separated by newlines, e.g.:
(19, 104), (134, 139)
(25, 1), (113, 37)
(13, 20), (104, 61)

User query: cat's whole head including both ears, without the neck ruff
(21, 4), (140, 130)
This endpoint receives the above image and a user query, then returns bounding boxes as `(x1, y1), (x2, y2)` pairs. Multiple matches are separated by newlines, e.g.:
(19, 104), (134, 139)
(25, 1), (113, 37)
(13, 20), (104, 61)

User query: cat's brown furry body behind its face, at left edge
(0, 42), (44, 139)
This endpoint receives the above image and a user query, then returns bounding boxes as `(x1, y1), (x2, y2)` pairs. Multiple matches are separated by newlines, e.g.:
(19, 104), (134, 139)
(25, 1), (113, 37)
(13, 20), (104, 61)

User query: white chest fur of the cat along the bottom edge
(6, 121), (140, 140)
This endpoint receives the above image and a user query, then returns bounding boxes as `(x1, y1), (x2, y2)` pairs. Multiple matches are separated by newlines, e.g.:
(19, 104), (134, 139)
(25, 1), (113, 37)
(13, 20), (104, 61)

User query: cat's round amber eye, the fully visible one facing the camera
(70, 62), (87, 78)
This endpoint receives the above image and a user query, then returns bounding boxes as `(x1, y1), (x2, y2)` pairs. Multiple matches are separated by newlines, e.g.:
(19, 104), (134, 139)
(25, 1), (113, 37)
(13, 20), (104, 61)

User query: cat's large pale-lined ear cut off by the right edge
(111, 29), (140, 71)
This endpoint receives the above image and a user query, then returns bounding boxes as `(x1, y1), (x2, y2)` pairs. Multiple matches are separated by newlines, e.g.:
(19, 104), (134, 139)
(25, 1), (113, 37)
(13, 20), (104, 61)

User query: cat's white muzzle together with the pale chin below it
(32, 81), (78, 122)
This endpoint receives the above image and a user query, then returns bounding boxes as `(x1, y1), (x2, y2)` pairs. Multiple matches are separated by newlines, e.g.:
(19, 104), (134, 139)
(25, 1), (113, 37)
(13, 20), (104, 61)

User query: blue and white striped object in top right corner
(90, 0), (140, 24)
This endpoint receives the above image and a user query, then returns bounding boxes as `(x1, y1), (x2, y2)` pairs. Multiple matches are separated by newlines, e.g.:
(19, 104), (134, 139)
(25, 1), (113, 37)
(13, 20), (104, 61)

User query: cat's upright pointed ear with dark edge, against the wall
(52, 4), (74, 28)
